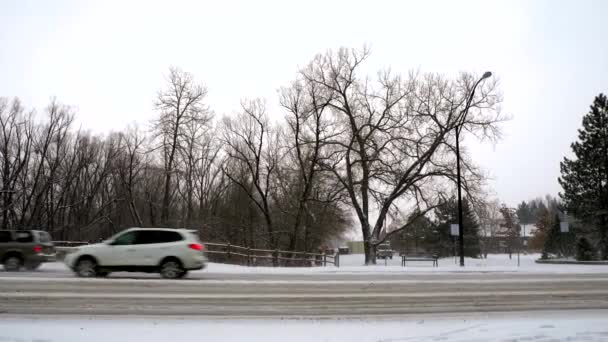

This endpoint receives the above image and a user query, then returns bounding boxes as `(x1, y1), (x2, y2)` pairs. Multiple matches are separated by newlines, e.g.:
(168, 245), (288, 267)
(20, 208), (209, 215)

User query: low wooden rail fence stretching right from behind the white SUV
(204, 242), (340, 267)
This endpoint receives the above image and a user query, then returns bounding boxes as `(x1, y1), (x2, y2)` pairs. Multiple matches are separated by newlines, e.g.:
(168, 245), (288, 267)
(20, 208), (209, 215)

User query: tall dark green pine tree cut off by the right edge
(558, 94), (608, 259)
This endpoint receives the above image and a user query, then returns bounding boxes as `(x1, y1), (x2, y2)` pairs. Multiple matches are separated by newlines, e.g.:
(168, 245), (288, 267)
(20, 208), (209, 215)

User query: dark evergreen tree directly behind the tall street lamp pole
(435, 198), (481, 258)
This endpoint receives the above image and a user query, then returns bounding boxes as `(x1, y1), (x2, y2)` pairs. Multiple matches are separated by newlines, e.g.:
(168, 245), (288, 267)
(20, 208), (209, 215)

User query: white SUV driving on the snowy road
(64, 228), (207, 279)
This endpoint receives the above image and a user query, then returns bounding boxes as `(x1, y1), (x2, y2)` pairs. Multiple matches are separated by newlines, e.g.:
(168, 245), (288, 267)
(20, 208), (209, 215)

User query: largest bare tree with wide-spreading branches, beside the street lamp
(302, 49), (500, 263)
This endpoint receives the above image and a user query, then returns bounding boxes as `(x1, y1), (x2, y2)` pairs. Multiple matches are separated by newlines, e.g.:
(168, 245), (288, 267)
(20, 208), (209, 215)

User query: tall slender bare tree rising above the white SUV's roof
(154, 68), (211, 224)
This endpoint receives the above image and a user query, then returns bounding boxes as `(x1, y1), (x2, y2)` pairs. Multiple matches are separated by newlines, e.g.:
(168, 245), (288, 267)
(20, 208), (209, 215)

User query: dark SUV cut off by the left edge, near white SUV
(0, 230), (56, 271)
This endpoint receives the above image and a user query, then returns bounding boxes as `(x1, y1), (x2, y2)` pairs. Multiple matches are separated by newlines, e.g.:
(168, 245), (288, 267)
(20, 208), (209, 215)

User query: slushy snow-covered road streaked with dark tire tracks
(0, 272), (608, 318)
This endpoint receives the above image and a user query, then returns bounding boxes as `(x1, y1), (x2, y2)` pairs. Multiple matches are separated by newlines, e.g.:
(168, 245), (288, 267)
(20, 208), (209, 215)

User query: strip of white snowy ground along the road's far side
(35, 254), (608, 274)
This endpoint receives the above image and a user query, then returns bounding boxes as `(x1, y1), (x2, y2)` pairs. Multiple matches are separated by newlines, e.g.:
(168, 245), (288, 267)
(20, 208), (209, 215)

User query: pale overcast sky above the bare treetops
(0, 0), (608, 205)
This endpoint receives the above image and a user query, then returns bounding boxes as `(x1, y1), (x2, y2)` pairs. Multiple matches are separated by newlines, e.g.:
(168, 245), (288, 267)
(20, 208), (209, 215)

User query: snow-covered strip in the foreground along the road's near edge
(0, 311), (608, 342)
